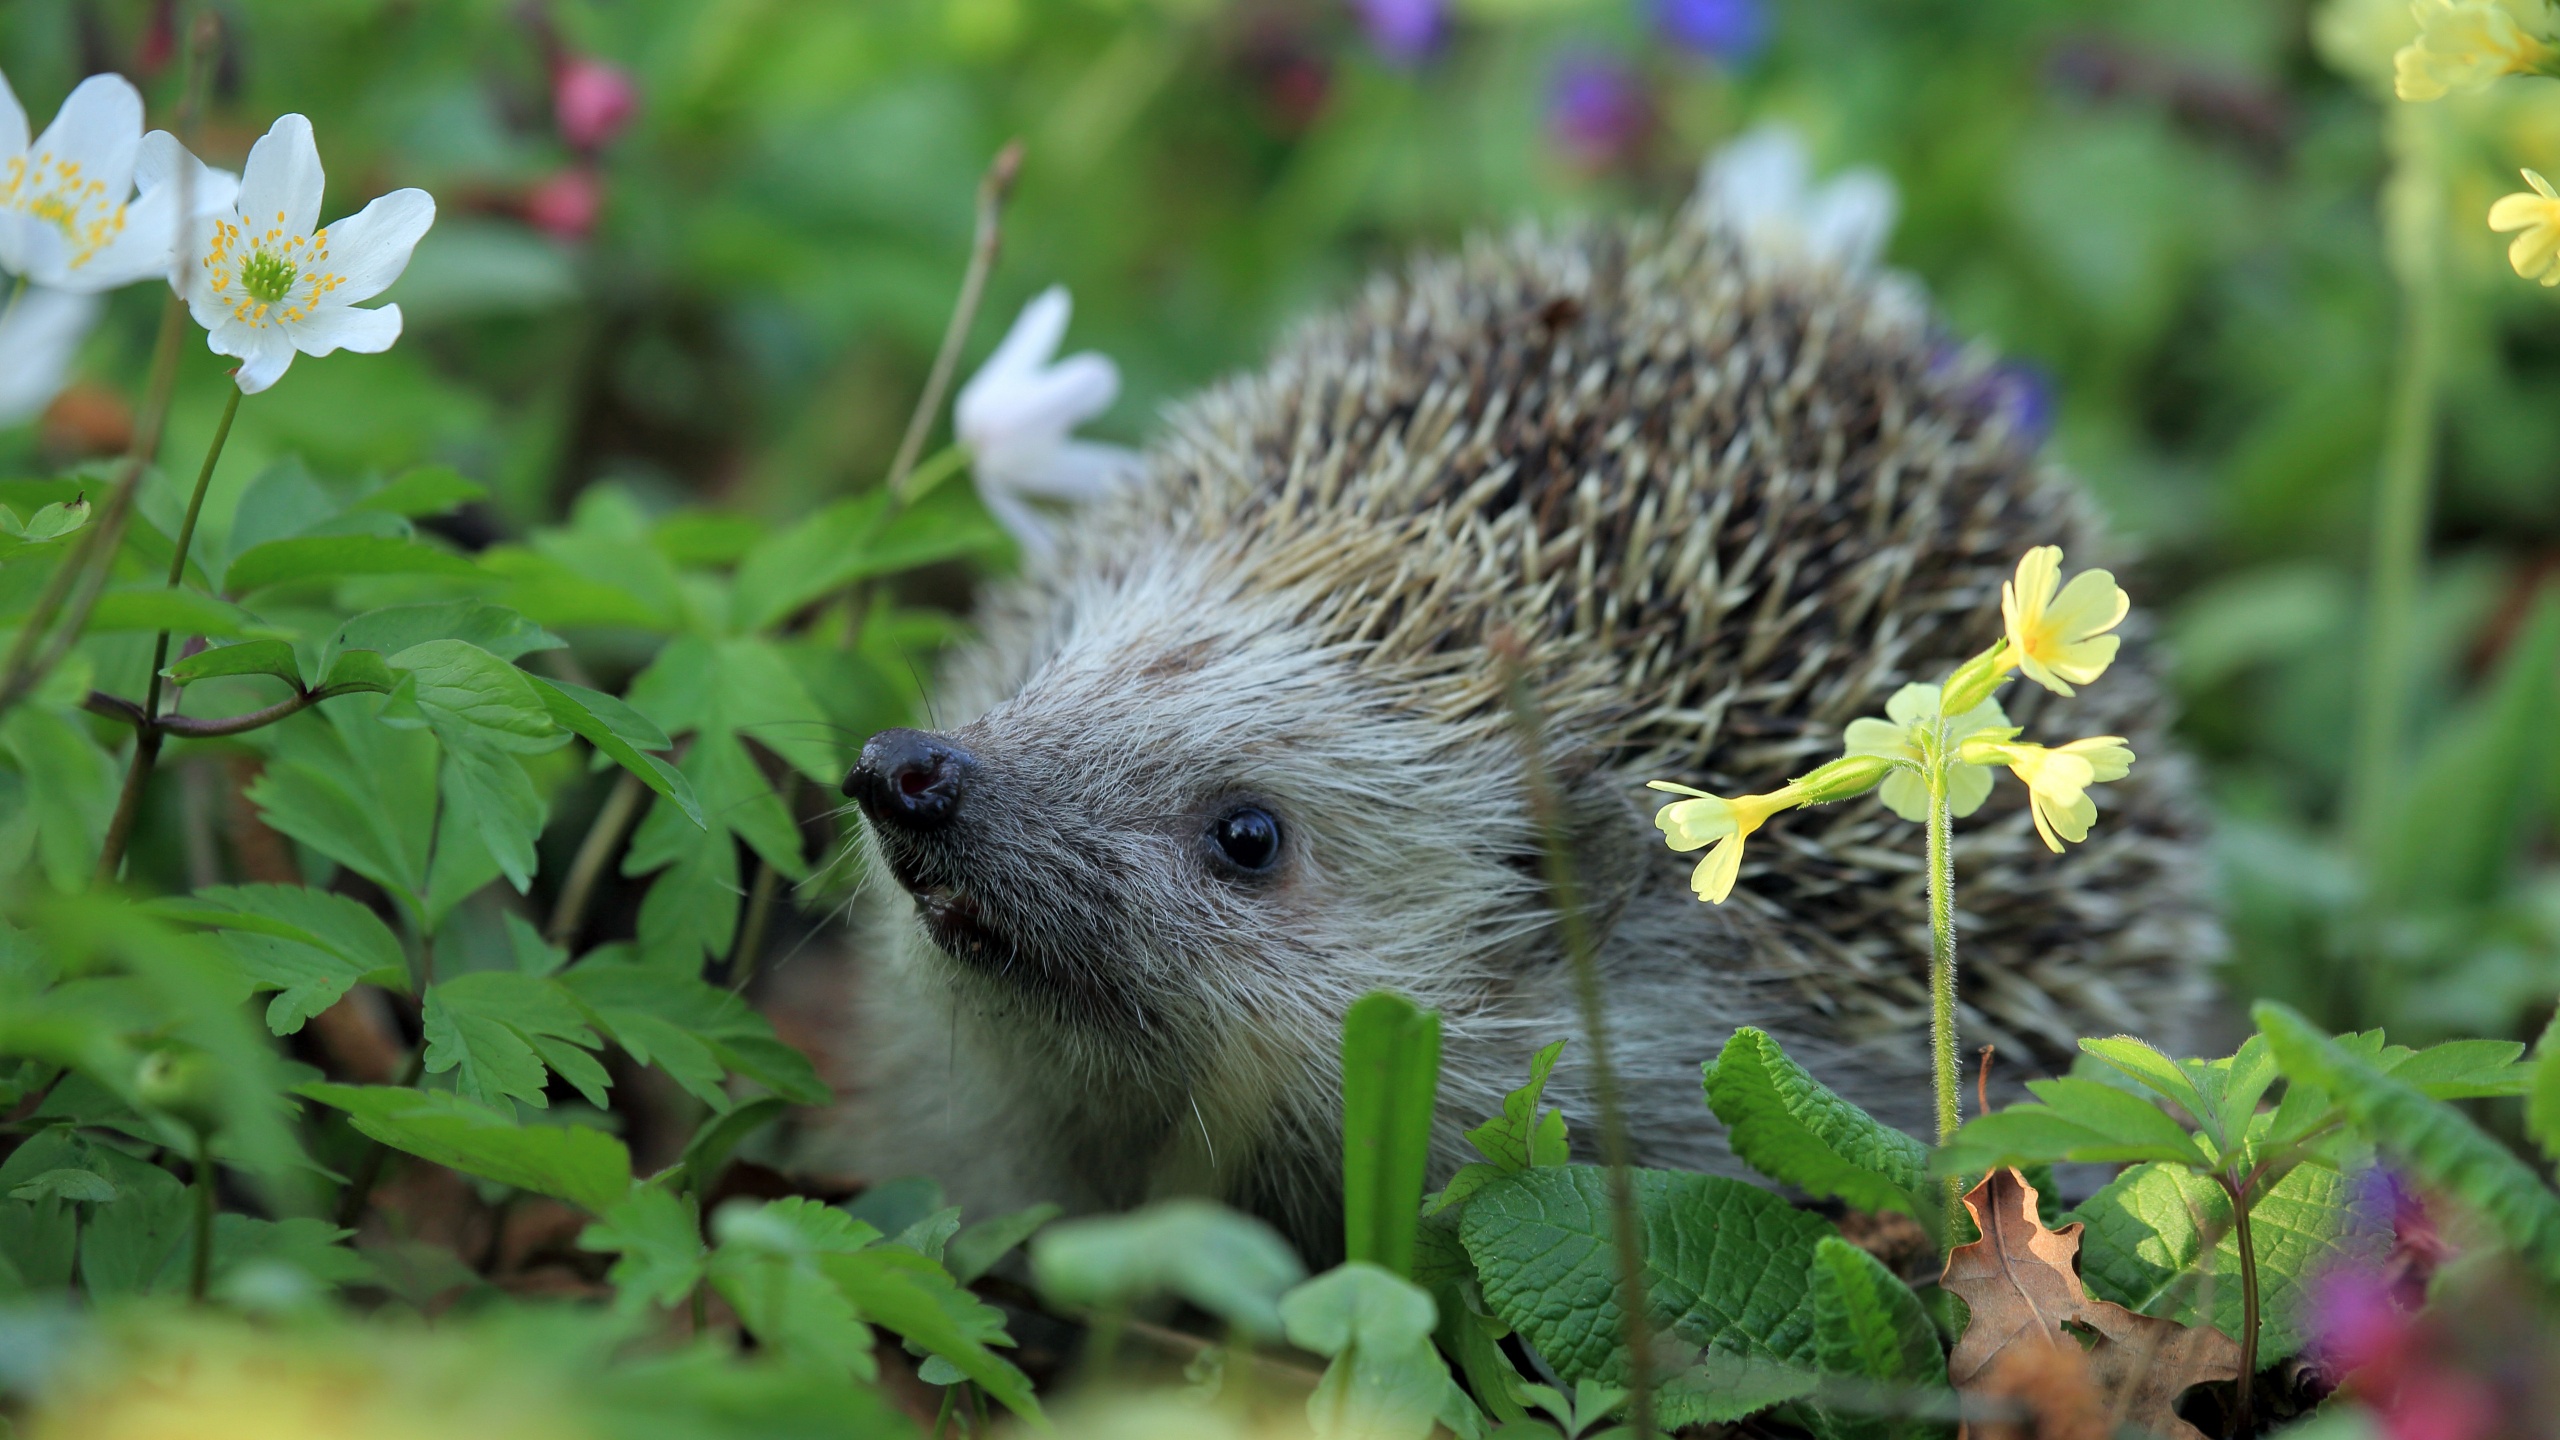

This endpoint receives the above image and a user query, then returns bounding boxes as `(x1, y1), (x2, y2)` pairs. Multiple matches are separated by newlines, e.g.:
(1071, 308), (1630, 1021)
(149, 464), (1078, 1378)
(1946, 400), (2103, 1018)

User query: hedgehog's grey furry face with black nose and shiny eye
(845, 548), (1541, 1058)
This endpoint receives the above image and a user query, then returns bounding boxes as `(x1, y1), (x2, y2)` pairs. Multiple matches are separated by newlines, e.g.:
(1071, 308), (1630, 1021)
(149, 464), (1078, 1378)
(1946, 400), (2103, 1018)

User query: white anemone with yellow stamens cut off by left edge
(0, 74), (233, 295)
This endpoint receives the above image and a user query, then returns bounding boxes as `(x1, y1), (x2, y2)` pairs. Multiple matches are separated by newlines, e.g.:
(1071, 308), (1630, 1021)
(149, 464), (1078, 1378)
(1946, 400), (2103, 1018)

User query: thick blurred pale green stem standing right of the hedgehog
(2345, 105), (2445, 876)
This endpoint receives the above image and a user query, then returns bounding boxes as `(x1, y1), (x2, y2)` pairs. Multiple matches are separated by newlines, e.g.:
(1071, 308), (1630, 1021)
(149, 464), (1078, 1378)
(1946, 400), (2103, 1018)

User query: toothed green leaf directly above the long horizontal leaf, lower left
(425, 971), (612, 1109)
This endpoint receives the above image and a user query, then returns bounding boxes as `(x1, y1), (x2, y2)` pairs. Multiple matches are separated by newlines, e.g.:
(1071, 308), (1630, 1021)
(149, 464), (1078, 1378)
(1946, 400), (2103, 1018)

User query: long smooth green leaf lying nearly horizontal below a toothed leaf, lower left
(297, 1081), (632, 1215)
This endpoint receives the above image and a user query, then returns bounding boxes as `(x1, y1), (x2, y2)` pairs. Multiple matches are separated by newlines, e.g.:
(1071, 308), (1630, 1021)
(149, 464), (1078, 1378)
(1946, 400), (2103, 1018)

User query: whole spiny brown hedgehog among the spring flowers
(837, 181), (2217, 1258)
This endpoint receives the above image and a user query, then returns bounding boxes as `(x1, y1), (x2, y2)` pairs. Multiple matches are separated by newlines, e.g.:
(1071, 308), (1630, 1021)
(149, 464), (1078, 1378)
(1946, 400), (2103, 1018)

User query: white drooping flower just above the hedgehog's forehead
(952, 284), (1137, 556)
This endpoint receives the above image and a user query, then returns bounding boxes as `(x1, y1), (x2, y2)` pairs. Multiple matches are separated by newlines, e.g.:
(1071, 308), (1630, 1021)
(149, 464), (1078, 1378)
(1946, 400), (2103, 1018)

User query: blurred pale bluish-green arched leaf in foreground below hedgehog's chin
(1032, 1199), (1306, 1340)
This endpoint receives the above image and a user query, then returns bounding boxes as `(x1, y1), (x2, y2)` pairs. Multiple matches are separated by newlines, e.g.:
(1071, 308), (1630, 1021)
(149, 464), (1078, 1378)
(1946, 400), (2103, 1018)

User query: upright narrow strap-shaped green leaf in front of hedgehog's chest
(1341, 992), (1439, 1276)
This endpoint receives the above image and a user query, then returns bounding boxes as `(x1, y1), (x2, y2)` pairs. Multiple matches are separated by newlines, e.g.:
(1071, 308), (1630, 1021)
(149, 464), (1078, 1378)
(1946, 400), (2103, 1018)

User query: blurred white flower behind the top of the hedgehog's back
(1700, 126), (1902, 272)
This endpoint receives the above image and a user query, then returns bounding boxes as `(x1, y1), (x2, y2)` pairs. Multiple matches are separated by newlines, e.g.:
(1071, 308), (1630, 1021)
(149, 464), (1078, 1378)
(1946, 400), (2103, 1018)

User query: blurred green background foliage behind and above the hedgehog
(15, 0), (2560, 1040)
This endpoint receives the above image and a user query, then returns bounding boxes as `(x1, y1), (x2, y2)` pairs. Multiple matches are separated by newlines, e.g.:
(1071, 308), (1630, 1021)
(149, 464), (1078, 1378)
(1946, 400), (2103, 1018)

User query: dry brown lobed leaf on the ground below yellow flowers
(1938, 1168), (2240, 1440)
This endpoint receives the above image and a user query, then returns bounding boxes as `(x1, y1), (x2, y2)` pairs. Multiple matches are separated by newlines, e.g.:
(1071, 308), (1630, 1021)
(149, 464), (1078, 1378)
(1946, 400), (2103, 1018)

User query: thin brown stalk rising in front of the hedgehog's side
(1495, 635), (1654, 1440)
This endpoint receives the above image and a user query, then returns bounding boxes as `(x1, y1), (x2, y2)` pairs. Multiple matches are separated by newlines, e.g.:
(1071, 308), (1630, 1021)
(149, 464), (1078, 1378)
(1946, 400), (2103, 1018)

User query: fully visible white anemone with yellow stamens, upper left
(179, 115), (435, 395)
